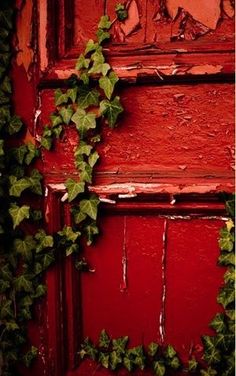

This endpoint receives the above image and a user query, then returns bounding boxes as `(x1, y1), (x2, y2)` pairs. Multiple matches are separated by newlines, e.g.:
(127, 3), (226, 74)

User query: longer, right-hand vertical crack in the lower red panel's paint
(159, 219), (167, 344)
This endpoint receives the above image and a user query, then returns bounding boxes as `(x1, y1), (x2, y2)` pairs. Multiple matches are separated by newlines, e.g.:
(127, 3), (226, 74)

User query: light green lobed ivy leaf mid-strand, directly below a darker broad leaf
(71, 108), (96, 139)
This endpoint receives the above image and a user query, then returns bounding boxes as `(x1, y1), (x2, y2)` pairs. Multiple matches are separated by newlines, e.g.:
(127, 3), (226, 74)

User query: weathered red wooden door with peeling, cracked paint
(14, 0), (234, 376)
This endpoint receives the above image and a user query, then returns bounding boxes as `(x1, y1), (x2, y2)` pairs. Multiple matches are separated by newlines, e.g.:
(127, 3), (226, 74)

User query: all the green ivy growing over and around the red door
(0, 1), (234, 376)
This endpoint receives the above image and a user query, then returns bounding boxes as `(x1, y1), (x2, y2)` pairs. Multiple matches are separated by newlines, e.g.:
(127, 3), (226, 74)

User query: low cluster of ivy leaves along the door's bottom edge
(79, 330), (181, 376)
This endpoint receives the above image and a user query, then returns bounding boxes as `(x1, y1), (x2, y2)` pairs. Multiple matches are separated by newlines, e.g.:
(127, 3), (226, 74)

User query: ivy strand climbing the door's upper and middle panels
(41, 13), (124, 268)
